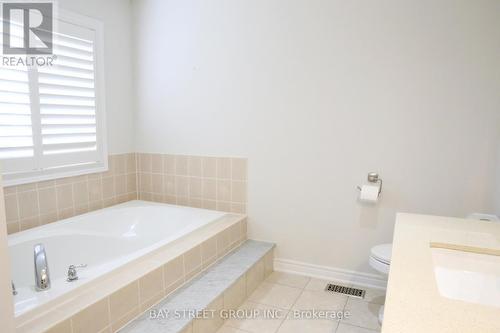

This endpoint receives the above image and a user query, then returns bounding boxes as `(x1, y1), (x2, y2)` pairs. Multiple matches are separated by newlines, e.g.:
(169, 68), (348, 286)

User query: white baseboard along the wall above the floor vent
(274, 258), (387, 289)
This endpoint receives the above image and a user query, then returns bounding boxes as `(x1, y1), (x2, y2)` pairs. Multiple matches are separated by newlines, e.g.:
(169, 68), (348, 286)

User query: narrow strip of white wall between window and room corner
(57, 0), (134, 153)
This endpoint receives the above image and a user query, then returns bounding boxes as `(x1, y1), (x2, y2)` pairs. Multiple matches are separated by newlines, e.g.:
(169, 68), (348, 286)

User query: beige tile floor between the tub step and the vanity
(218, 272), (385, 333)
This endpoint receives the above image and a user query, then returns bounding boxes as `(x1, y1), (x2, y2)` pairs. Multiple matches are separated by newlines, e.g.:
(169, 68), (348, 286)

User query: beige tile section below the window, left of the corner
(4, 153), (137, 234)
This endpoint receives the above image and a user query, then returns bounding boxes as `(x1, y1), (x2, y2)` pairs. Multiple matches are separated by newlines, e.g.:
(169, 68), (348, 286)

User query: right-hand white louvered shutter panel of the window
(38, 23), (99, 167)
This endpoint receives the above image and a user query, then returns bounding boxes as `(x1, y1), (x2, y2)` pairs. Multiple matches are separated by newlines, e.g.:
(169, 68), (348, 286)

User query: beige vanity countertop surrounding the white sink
(382, 214), (500, 333)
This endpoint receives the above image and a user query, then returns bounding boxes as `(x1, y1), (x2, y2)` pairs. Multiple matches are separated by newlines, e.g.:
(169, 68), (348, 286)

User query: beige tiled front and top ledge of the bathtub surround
(16, 214), (246, 333)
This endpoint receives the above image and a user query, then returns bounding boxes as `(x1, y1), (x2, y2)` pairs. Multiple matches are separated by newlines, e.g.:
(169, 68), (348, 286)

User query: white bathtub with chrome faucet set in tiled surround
(8, 200), (226, 317)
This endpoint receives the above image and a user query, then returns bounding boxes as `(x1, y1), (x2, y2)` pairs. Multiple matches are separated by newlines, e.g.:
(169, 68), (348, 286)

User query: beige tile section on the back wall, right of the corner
(137, 154), (247, 213)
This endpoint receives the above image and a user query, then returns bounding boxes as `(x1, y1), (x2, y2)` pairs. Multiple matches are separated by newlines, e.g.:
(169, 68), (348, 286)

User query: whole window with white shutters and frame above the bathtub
(0, 13), (107, 185)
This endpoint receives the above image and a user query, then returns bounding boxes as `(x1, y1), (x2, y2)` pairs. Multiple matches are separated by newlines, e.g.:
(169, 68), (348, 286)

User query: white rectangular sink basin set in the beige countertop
(431, 243), (500, 307)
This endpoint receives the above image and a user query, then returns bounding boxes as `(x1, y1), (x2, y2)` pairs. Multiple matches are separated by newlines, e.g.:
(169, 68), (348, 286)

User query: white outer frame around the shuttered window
(0, 8), (108, 186)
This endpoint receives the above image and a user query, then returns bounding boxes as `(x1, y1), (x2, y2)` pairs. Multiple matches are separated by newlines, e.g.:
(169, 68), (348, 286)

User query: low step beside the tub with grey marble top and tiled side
(120, 240), (274, 333)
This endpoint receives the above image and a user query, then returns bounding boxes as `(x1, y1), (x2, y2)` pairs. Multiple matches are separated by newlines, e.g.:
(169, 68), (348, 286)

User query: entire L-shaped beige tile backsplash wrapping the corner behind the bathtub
(4, 153), (247, 234)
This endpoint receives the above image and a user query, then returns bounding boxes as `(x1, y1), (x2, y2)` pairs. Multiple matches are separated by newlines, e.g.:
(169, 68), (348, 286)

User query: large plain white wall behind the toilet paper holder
(133, 0), (500, 272)
